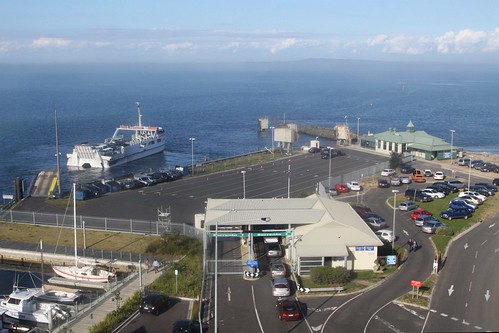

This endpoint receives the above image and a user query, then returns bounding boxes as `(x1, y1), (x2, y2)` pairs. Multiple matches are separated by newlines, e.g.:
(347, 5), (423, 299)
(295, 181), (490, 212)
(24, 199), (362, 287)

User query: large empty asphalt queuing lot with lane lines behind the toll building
(11, 149), (387, 225)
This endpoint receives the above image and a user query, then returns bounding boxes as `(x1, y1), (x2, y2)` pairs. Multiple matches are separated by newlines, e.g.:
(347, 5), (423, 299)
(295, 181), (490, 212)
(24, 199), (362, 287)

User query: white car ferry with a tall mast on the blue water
(67, 103), (166, 169)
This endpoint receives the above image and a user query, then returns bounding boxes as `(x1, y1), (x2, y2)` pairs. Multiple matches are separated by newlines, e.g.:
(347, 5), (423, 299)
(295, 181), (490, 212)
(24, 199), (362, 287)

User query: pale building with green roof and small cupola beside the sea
(361, 121), (459, 160)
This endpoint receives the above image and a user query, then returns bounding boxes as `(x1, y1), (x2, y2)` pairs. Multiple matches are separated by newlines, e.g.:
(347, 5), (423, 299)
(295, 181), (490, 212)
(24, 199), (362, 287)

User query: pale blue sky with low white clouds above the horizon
(0, 0), (499, 64)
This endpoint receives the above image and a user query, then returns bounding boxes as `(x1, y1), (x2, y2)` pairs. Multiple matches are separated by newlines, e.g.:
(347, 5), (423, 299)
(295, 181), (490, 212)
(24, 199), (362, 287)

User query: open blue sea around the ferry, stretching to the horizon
(0, 60), (499, 194)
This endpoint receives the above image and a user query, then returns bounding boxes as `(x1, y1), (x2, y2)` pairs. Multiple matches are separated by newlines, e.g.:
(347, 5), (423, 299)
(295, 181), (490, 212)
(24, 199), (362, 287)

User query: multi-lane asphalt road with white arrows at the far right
(425, 220), (499, 332)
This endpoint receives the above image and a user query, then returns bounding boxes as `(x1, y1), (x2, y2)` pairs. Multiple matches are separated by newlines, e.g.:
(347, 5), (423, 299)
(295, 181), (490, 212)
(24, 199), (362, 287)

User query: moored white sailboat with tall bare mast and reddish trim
(52, 184), (115, 282)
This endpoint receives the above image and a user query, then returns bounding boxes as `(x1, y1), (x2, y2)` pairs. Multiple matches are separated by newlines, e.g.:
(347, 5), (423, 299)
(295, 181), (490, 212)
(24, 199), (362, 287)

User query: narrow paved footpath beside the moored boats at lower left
(59, 267), (163, 333)
